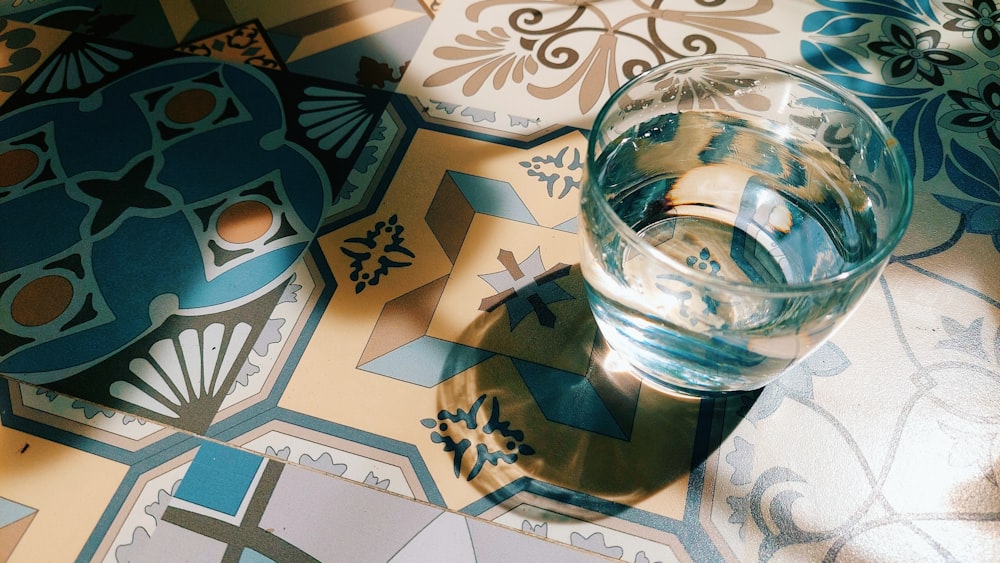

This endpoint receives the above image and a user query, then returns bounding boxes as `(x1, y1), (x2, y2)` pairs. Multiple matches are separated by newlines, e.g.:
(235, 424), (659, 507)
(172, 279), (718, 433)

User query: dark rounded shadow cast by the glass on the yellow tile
(434, 266), (756, 510)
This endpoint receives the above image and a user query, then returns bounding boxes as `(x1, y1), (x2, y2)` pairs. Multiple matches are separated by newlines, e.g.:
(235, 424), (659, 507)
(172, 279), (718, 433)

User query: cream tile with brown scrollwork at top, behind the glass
(400, 0), (803, 127)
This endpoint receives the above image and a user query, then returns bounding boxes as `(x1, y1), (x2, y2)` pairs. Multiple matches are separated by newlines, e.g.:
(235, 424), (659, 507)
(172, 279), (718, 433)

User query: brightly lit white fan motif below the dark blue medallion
(109, 323), (252, 418)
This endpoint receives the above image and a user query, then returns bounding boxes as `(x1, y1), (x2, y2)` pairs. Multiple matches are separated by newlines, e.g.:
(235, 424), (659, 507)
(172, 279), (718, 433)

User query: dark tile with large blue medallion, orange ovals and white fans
(0, 33), (386, 431)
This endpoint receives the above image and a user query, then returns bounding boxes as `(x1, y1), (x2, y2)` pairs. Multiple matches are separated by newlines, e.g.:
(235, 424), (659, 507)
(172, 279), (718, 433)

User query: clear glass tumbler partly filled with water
(579, 55), (913, 395)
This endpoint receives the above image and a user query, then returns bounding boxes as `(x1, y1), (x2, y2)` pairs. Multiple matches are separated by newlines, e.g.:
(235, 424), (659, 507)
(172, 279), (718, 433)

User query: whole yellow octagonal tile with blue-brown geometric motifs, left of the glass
(278, 92), (712, 556)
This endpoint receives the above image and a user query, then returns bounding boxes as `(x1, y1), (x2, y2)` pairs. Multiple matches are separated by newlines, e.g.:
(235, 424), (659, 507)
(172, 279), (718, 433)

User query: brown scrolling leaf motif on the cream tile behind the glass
(423, 0), (778, 114)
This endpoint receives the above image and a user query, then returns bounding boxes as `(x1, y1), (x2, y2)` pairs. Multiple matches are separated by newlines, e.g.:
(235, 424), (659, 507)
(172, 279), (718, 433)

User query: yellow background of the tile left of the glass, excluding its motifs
(280, 130), (698, 518)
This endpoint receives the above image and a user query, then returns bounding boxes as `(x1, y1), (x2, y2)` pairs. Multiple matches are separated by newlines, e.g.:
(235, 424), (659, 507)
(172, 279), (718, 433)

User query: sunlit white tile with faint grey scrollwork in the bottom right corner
(706, 264), (1000, 561)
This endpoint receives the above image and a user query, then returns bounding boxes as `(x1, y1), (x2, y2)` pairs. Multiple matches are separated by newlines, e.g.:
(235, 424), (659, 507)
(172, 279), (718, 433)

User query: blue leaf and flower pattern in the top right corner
(801, 0), (1000, 255)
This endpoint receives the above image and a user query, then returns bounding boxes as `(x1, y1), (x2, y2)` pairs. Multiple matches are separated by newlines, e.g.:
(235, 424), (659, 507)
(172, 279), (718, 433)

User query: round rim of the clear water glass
(581, 54), (914, 296)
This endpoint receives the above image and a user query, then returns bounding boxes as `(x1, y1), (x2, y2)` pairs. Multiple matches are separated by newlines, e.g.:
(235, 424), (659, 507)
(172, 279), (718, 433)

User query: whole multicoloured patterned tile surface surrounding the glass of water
(0, 0), (1000, 561)
